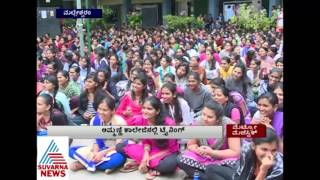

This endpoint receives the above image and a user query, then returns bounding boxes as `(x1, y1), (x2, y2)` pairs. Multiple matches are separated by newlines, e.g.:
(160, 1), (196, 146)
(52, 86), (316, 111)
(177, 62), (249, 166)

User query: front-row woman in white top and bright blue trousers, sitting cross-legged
(69, 96), (127, 173)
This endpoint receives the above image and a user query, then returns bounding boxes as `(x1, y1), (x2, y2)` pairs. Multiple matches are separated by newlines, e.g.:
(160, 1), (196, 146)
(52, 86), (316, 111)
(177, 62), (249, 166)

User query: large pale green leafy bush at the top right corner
(230, 4), (276, 32)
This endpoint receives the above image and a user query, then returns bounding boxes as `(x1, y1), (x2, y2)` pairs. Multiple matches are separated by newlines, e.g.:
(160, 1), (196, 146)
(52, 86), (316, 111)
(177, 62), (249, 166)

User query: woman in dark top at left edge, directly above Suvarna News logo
(37, 94), (68, 136)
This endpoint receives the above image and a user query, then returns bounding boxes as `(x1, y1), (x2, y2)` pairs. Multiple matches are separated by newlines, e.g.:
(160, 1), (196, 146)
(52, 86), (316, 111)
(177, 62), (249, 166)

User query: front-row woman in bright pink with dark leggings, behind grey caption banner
(116, 96), (179, 179)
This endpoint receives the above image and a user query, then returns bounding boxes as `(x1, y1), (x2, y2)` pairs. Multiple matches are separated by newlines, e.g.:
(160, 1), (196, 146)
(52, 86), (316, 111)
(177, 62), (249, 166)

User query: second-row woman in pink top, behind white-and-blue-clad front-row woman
(116, 73), (148, 125)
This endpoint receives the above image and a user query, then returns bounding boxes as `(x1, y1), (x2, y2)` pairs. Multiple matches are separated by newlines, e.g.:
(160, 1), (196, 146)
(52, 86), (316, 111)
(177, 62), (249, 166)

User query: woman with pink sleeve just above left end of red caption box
(213, 86), (244, 124)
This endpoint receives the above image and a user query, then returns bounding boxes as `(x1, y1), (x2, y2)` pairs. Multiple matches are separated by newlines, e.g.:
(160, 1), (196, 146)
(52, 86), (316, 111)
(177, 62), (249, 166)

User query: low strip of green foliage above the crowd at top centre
(164, 15), (204, 31)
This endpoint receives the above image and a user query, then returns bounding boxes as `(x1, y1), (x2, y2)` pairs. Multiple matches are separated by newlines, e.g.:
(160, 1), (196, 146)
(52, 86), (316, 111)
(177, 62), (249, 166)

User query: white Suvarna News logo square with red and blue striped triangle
(37, 136), (69, 180)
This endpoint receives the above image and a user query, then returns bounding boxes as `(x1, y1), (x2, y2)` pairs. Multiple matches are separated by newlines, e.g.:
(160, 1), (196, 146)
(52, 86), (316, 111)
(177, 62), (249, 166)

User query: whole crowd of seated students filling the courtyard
(37, 15), (284, 180)
